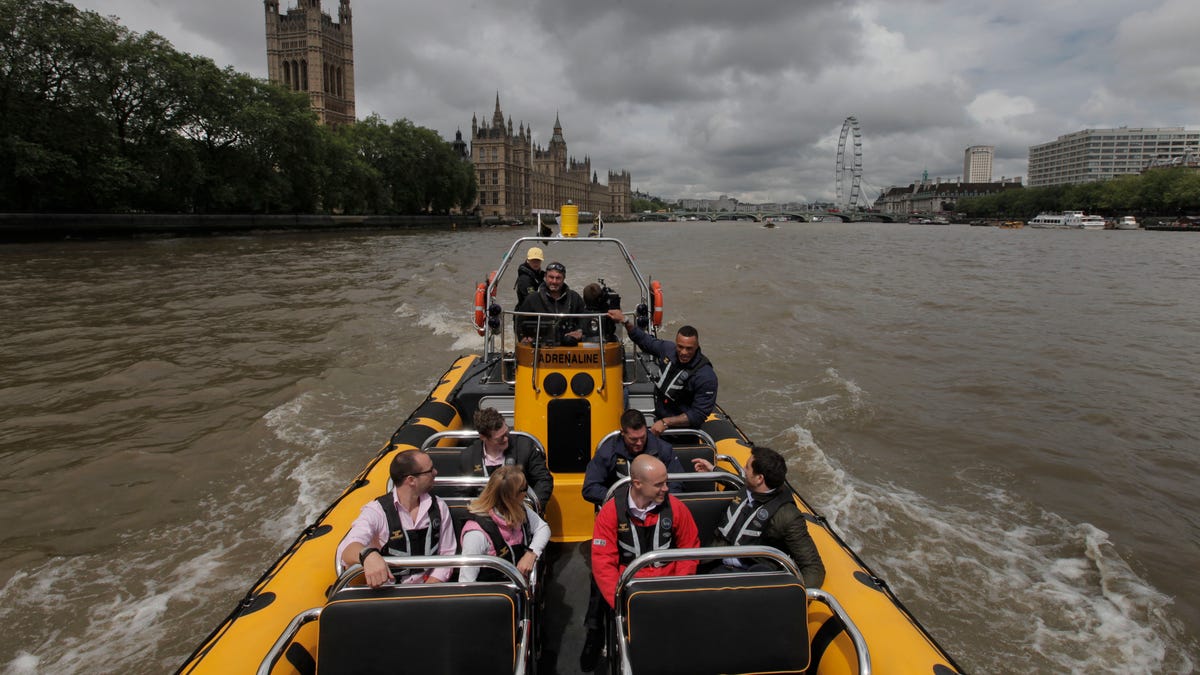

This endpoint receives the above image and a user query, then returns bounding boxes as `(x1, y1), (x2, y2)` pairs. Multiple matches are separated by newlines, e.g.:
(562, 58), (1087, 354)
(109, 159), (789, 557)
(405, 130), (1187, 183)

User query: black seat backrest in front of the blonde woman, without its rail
(317, 583), (521, 675)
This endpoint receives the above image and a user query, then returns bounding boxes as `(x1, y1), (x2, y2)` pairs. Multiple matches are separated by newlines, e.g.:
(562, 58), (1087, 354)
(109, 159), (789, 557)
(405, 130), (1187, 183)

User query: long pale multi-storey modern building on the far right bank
(1028, 126), (1200, 187)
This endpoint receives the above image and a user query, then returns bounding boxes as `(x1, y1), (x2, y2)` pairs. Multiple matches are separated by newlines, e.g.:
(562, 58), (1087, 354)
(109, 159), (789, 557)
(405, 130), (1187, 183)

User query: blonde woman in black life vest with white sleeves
(458, 465), (550, 581)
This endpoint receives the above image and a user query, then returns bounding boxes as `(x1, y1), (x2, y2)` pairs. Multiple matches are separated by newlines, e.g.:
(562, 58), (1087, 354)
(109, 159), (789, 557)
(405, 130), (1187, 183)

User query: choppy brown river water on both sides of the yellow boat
(0, 222), (1200, 674)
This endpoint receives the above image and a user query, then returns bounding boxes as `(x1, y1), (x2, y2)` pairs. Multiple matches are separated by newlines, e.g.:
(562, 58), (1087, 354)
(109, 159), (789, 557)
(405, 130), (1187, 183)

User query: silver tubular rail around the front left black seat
(257, 555), (538, 675)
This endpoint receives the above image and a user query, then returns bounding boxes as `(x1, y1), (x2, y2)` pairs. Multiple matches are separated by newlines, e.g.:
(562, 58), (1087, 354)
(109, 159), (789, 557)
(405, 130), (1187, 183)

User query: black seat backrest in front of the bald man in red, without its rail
(618, 572), (809, 675)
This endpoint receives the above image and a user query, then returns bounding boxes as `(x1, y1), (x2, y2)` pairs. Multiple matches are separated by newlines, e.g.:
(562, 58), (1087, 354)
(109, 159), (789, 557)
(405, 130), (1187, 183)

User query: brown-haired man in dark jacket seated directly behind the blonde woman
(458, 401), (554, 512)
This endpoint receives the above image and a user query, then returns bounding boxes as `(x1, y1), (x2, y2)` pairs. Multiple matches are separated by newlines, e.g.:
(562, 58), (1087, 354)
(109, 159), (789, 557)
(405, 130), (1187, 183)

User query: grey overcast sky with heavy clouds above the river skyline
(73, 0), (1200, 202)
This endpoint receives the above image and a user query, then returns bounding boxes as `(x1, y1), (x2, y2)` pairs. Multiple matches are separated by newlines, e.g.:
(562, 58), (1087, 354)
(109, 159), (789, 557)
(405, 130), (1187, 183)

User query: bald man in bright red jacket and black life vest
(592, 454), (700, 607)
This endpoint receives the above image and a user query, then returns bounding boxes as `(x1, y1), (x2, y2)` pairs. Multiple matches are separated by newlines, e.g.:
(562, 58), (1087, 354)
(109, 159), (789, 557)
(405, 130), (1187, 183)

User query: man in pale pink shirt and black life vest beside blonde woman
(337, 450), (457, 589)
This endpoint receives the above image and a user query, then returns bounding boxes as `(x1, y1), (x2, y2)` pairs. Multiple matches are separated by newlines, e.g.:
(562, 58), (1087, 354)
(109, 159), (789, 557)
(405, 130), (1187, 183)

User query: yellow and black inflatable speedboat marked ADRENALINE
(181, 211), (959, 675)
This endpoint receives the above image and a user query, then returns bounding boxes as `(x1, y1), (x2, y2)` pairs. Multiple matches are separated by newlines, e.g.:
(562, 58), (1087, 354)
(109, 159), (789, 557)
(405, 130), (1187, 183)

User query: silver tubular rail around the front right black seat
(613, 546), (871, 675)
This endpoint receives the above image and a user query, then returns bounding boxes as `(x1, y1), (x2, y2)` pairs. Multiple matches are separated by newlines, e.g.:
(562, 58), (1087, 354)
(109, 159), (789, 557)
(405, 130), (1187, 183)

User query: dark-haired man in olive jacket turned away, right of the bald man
(691, 446), (824, 589)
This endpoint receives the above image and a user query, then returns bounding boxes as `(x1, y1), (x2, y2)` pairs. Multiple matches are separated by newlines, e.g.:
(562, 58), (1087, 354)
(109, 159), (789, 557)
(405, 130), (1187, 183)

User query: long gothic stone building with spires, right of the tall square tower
(470, 94), (631, 220)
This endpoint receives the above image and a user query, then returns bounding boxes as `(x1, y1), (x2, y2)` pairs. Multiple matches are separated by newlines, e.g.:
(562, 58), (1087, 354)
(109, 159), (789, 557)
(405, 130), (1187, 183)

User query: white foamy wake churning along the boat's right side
(776, 425), (1200, 673)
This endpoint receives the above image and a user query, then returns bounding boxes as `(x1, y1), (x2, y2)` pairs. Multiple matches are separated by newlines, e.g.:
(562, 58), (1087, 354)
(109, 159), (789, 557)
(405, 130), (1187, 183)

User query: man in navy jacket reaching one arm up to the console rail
(608, 310), (716, 435)
